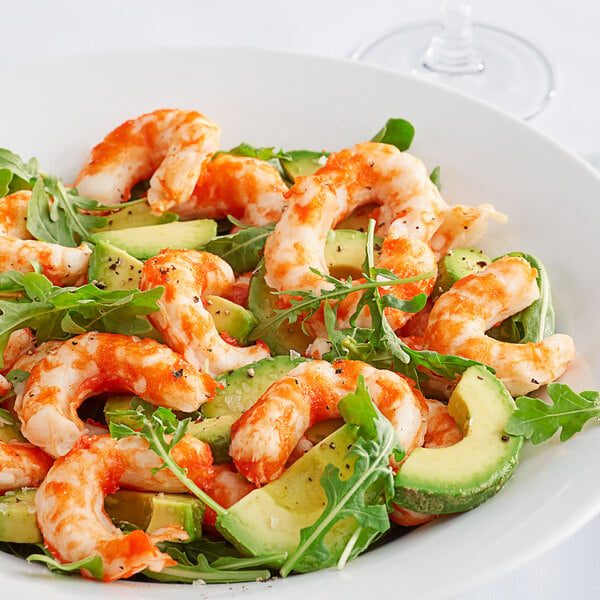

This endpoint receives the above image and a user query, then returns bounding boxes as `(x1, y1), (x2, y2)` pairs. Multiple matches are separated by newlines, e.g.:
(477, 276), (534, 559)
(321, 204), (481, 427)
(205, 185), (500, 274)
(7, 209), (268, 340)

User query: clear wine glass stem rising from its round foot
(422, 0), (485, 75)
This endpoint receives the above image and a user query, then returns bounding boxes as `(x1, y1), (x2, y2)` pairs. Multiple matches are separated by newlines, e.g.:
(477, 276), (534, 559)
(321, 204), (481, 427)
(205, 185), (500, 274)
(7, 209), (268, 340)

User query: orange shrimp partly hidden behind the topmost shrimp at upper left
(174, 154), (288, 225)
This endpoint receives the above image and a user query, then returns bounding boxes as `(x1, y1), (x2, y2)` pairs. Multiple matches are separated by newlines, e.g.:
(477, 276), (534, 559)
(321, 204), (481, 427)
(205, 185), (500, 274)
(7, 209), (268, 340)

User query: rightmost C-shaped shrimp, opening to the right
(424, 256), (575, 396)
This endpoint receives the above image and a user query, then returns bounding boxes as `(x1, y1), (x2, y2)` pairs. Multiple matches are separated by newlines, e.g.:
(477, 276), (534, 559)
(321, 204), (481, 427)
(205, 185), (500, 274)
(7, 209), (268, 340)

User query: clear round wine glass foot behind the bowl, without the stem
(351, 22), (555, 119)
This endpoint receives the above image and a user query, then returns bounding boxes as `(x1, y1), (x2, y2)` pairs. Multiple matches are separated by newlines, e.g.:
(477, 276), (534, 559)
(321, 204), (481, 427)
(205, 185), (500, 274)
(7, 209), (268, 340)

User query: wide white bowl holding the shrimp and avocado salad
(0, 49), (600, 600)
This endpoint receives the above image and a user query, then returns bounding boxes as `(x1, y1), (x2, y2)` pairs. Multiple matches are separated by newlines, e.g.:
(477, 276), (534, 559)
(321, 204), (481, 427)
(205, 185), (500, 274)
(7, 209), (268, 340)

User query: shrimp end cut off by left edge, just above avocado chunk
(0, 441), (53, 494)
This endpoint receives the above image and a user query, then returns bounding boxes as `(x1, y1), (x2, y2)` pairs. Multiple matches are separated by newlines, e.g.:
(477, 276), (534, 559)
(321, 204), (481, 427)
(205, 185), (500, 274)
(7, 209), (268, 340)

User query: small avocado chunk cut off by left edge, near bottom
(0, 488), (43, 544)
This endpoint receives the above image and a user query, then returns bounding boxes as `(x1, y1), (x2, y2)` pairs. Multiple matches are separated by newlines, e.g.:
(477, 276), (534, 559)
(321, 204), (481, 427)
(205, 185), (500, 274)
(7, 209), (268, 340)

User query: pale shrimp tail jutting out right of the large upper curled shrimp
(431, 204), (507, 260)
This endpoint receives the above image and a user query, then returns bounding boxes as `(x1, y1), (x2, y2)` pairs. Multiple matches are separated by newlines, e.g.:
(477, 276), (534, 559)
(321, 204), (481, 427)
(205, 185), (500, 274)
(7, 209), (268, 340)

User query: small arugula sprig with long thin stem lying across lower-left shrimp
(109, 406), (227, 515)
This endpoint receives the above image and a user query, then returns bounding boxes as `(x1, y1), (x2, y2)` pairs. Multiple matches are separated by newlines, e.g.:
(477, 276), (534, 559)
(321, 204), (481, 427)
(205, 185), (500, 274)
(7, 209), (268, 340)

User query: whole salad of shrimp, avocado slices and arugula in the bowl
(0, 109), (600, 583)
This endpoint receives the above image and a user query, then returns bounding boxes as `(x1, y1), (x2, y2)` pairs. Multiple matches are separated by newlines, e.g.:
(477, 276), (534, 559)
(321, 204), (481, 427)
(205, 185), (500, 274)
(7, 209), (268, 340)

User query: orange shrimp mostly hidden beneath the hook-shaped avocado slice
(390, 399), (463, 527)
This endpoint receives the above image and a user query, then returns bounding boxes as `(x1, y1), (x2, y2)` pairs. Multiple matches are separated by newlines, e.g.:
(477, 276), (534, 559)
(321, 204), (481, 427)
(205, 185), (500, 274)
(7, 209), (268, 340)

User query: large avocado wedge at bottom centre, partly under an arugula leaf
(217, 425), (364, 568)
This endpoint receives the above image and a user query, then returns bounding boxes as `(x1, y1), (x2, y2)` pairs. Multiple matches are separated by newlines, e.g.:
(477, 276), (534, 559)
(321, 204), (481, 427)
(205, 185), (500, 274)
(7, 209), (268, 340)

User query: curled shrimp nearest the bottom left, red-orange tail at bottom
(35, 437), (195, 581)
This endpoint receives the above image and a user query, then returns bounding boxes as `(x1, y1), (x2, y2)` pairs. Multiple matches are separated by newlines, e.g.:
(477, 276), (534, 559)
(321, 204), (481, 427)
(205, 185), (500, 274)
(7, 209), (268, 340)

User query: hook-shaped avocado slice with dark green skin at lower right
(394, 366), (523, 515)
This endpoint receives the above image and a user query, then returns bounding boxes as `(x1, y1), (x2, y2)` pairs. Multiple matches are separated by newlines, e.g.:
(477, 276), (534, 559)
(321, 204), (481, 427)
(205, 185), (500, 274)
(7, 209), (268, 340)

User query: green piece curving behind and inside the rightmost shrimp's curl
(487, 252), (555, 344)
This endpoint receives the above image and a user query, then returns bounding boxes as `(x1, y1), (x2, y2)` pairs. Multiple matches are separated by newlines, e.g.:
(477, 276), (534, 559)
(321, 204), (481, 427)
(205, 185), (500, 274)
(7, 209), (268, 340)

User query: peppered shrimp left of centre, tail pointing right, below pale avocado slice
(140, 250), (269, 376)
